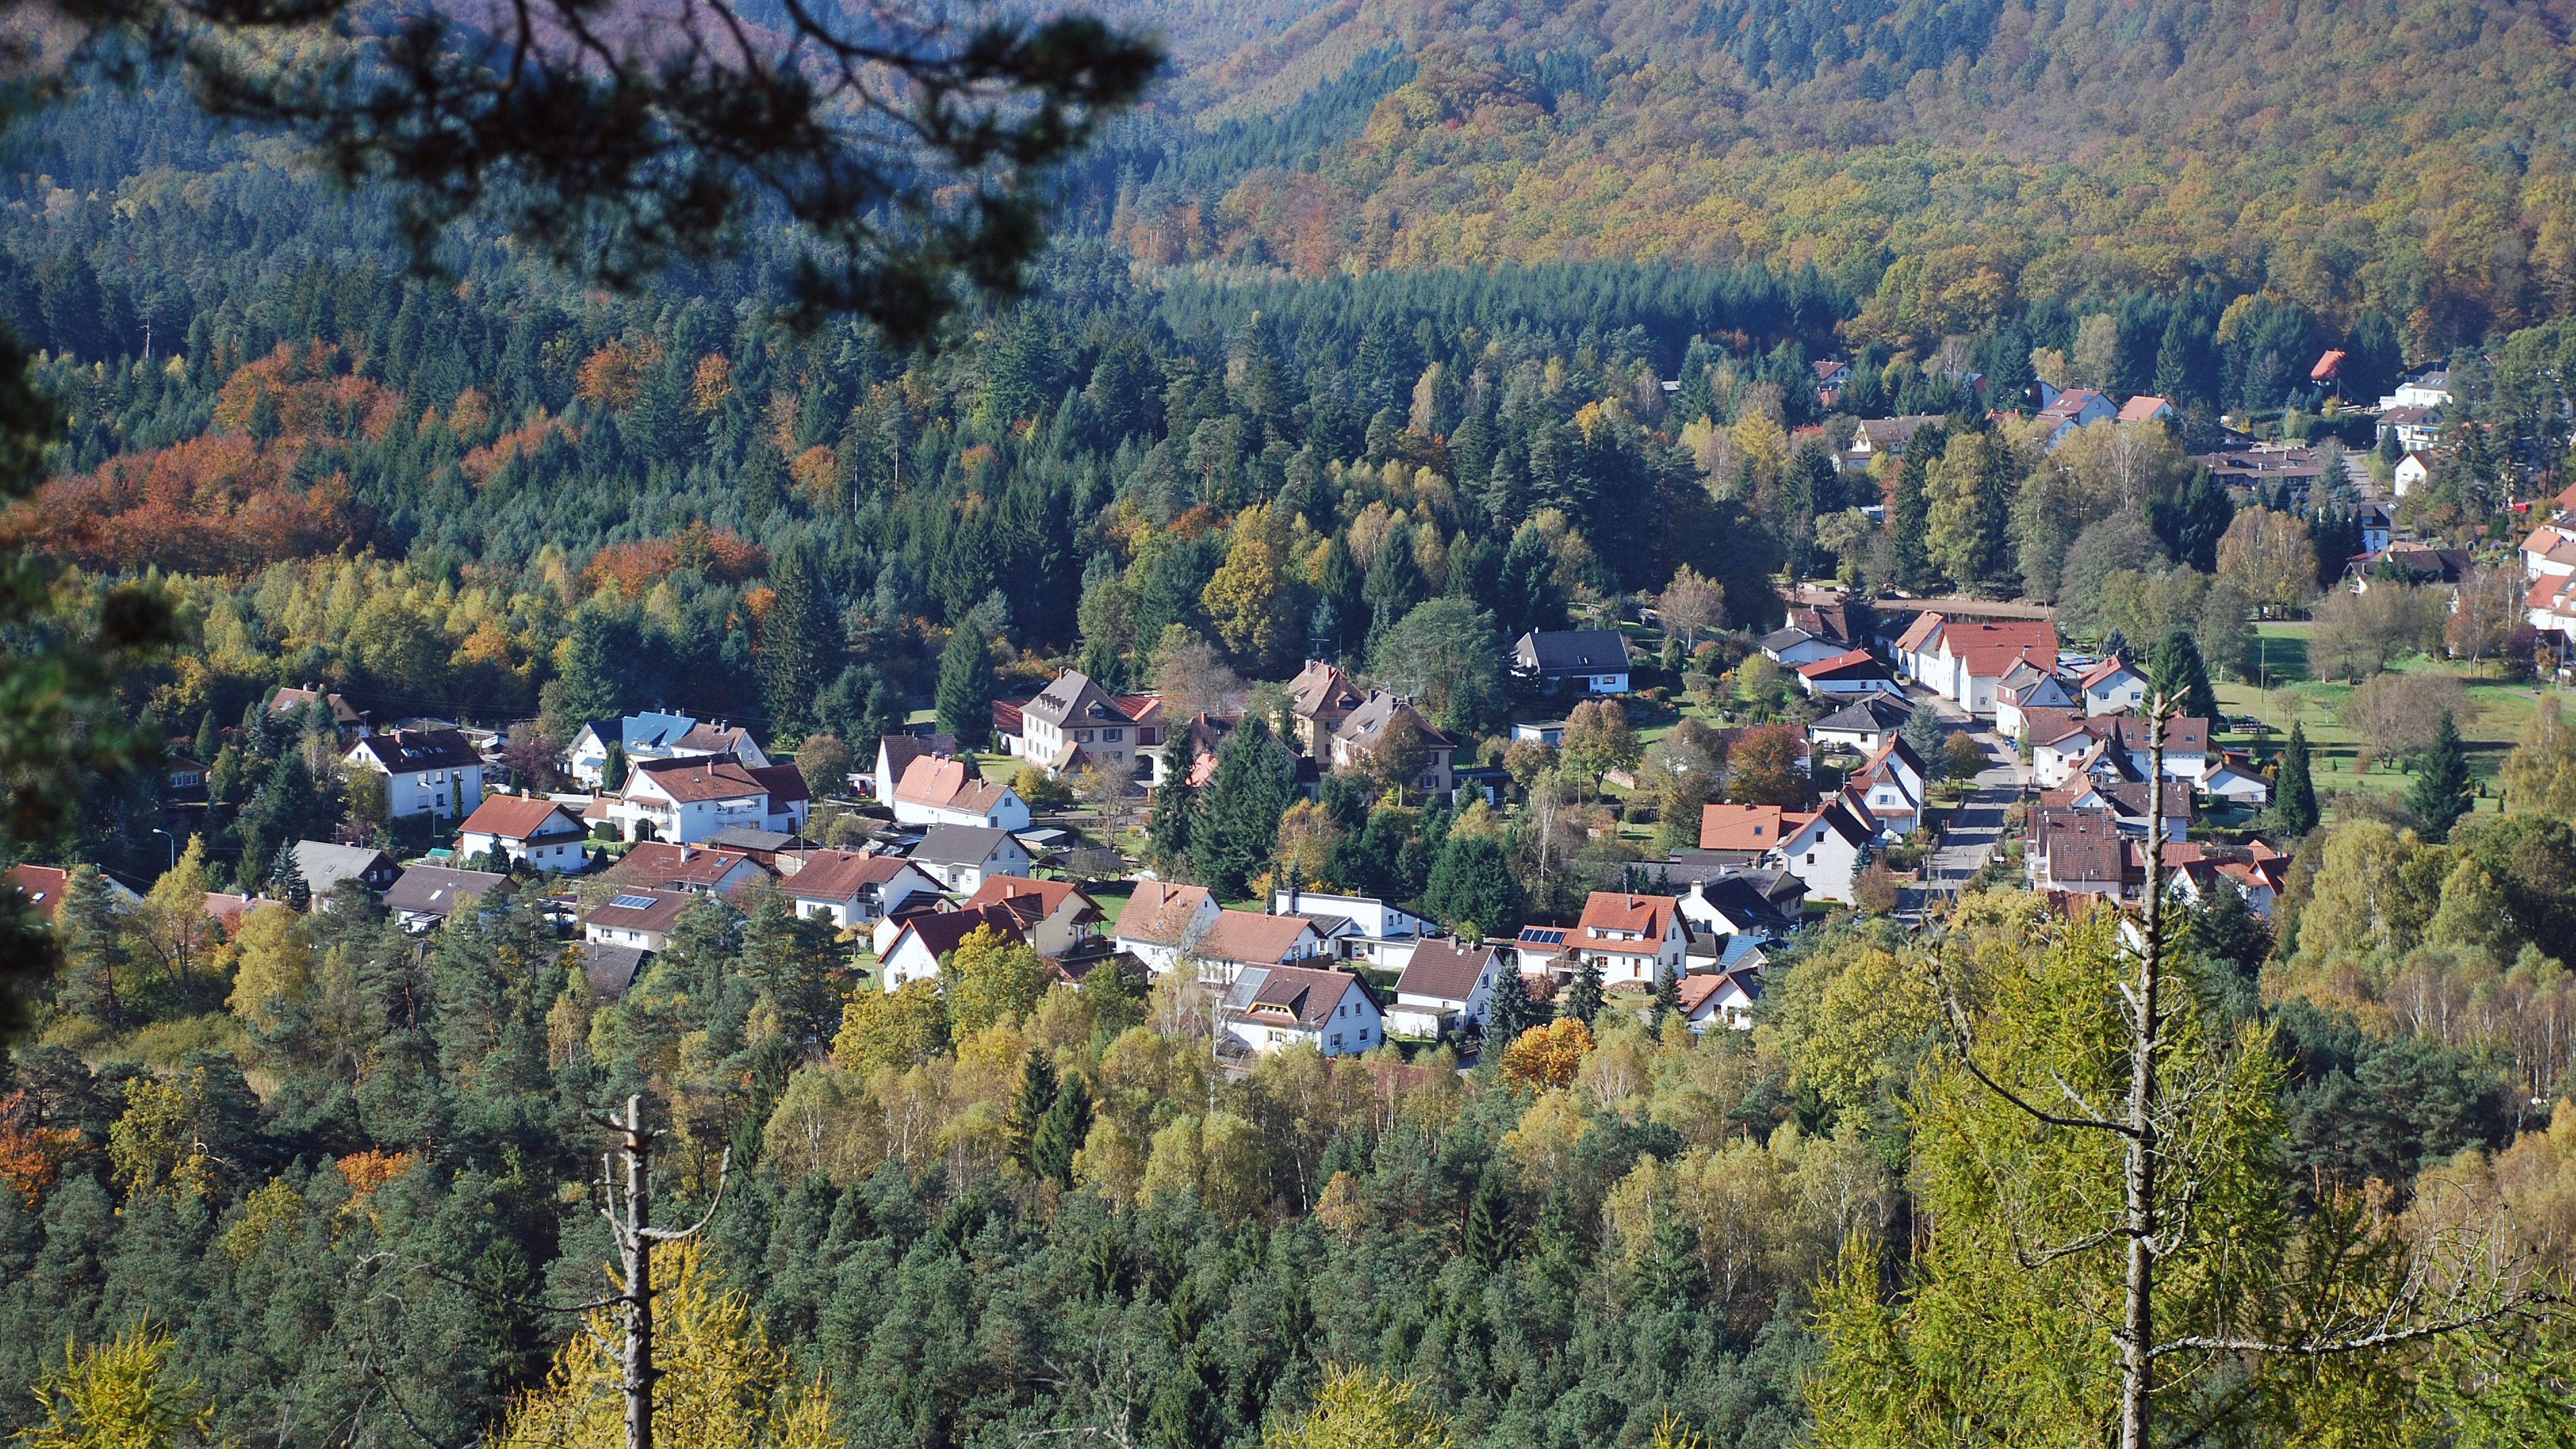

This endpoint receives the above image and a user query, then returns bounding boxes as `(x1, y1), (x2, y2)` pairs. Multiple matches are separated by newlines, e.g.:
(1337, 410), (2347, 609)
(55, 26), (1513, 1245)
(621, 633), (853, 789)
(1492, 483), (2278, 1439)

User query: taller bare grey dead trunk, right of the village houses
(2120, 692), (2169, 1449)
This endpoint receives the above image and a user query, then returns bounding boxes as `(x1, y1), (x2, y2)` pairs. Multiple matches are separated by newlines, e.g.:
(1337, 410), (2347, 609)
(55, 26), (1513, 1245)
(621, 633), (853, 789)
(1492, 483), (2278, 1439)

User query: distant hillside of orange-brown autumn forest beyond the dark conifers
(1118, 0), (2576, 350)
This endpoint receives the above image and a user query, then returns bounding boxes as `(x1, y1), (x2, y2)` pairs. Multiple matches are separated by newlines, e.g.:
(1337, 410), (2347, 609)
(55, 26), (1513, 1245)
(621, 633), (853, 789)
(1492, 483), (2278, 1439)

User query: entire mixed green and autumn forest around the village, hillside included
(0, 0), (2576, 1449)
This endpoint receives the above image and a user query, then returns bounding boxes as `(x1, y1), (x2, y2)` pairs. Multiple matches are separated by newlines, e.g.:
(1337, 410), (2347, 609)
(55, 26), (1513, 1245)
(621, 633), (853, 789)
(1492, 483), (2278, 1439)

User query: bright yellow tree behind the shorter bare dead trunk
(512, 1243), (843, 1449)
